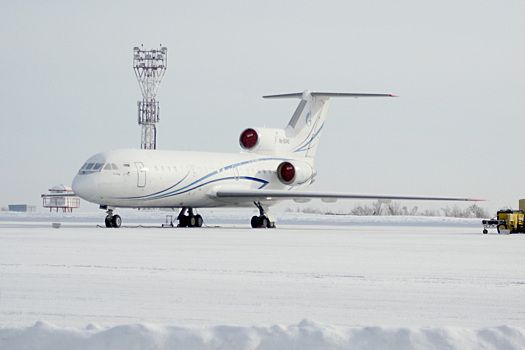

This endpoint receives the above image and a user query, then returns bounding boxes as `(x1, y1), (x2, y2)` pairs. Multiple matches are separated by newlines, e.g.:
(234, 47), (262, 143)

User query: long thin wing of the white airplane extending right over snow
(215, 189), (485, 203)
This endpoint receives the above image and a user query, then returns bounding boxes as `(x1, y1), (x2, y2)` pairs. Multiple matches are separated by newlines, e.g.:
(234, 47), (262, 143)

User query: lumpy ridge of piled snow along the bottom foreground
(0, 320), (525, 350)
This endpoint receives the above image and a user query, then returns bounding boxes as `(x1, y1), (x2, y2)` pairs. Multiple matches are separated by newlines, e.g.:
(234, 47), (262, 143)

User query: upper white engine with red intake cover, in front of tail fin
(239, 128), (290, 155)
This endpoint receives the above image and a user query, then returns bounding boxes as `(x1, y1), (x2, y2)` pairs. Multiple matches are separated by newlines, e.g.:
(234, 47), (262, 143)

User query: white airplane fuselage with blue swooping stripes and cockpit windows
(73, 149), (315, 208)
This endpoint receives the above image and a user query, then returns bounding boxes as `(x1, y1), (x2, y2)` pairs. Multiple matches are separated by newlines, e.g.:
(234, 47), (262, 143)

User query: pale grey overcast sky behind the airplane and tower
(0, 0), (525, 211)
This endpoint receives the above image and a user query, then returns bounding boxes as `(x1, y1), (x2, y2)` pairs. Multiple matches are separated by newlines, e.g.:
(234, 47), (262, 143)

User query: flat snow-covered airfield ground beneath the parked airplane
(0, 210), (525, 350)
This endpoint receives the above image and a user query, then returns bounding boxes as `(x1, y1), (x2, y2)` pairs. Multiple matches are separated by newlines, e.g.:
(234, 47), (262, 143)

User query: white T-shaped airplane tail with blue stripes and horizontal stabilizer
(263, 91), (394, 162)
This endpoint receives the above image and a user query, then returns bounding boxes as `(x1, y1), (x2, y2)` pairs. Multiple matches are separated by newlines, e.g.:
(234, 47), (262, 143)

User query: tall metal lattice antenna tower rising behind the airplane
(133, 45), (168, 149)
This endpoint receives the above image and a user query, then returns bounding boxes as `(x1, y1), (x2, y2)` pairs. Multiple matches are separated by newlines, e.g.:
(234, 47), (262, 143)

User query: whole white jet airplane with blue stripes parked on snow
(68, 91), (474, 228)
